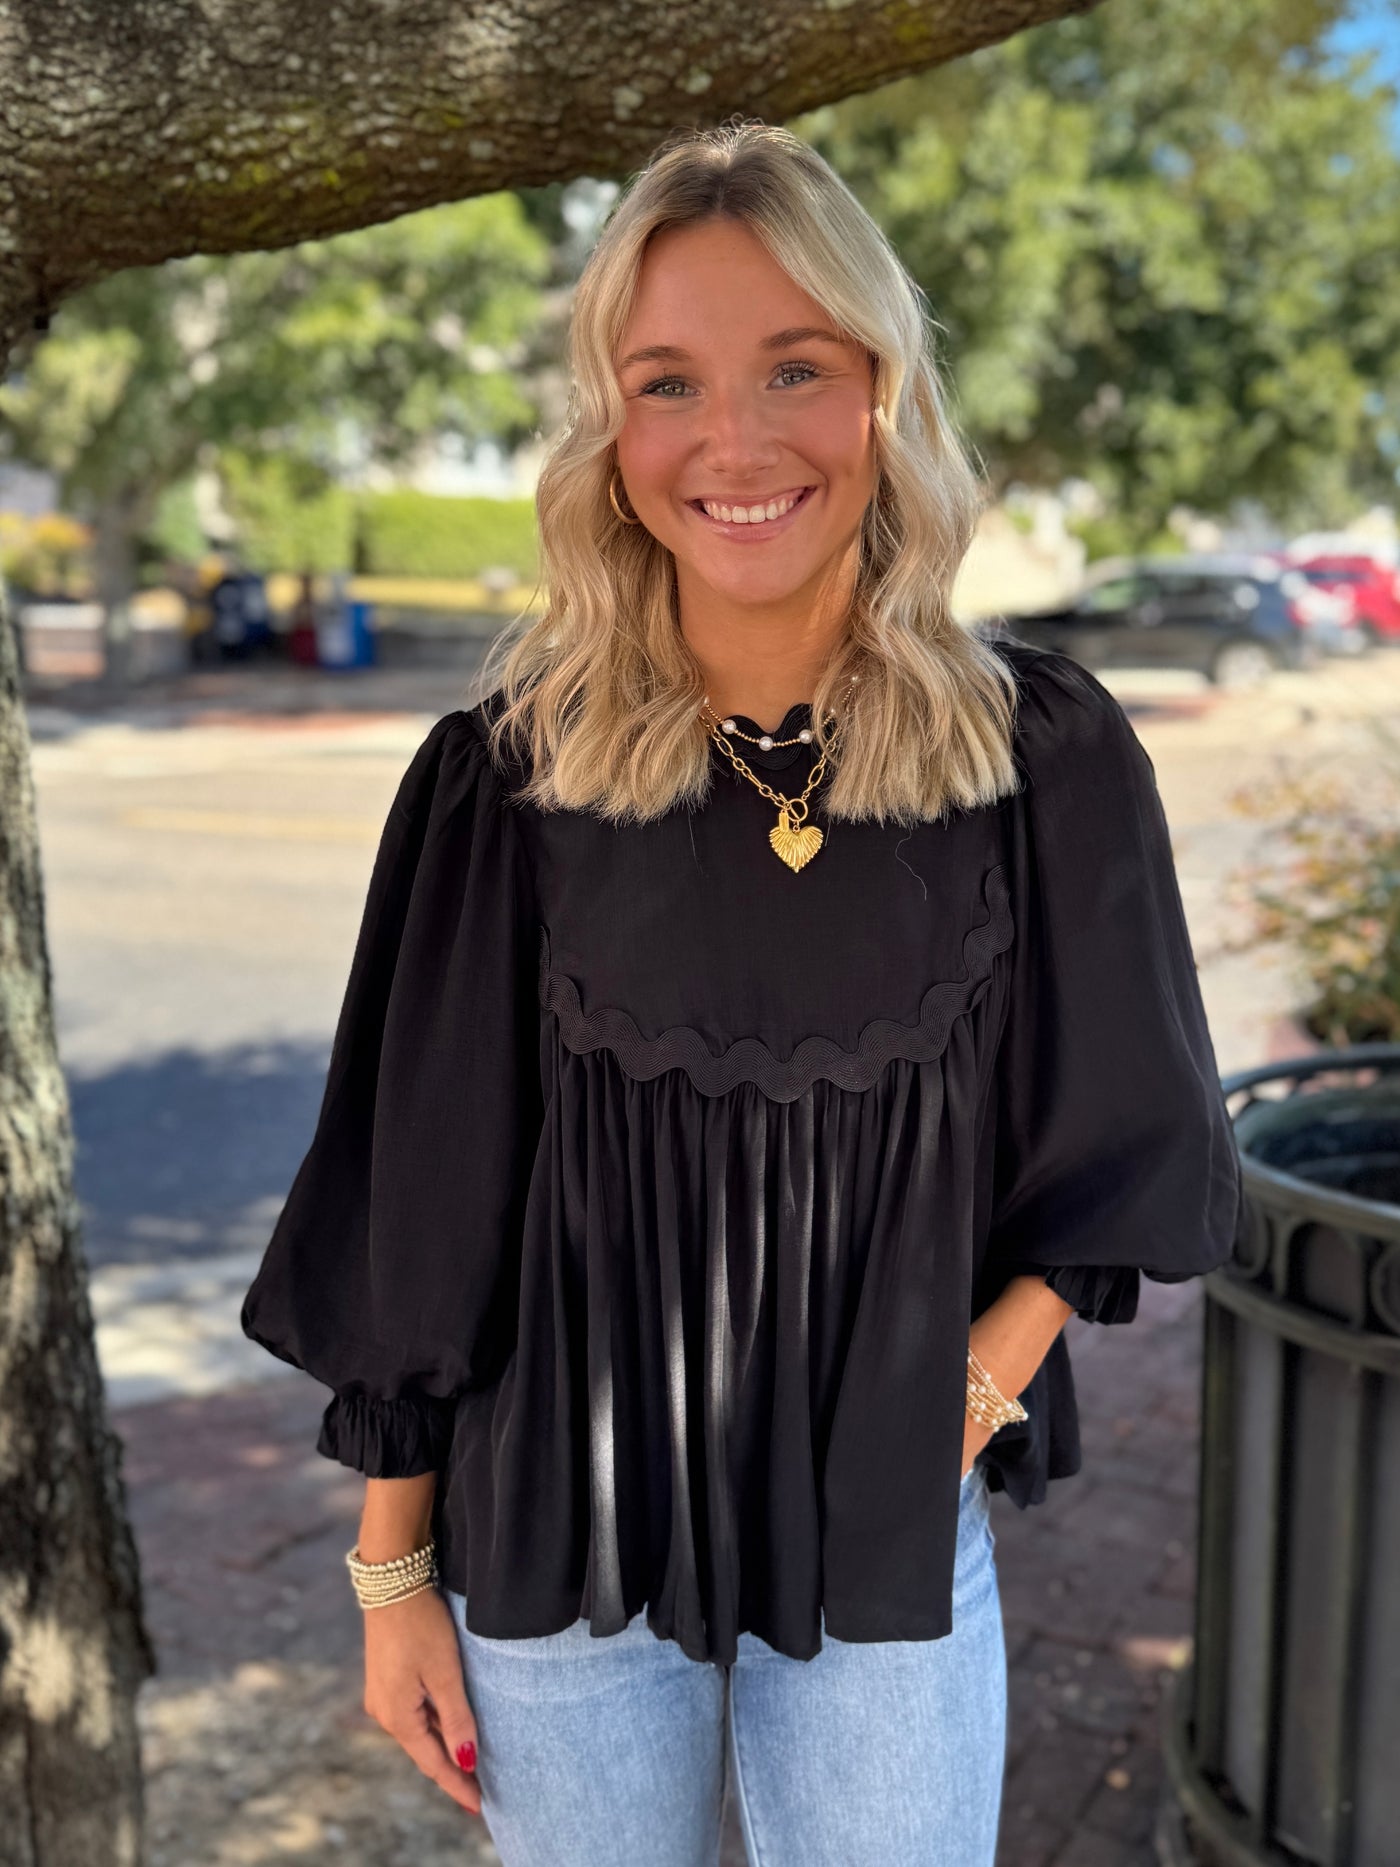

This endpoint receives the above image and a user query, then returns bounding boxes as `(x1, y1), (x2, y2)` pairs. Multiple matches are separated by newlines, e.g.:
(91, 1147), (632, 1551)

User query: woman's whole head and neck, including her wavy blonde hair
(487, 109), (1014, 823)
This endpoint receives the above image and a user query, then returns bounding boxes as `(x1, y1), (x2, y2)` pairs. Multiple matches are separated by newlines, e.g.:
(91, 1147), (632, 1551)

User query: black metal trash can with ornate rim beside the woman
(1165, 1044), (1400, 1867)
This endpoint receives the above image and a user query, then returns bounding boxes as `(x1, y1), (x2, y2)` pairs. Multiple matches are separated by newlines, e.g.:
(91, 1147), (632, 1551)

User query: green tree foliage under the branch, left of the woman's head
(0, 194), (551, 623)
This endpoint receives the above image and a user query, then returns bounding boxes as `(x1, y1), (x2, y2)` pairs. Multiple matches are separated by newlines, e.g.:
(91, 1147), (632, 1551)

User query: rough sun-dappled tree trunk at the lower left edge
(0, 588), (155, 1867)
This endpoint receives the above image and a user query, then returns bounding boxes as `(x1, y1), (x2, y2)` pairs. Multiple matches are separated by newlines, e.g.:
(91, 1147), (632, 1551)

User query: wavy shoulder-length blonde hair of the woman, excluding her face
(480, 119), (1015, 823)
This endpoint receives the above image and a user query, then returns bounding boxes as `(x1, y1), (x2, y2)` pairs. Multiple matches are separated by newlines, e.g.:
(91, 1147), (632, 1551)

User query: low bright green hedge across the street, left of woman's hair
(220, 456), (539, 583)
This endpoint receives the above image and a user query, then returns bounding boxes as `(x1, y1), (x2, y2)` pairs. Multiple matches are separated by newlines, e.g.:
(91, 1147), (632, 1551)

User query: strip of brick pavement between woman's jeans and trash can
(993, 1279), (1202, 1867)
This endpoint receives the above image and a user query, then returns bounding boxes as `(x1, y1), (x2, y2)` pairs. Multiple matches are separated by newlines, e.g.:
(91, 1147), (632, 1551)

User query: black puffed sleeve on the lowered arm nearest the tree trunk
(241, 711), (543, 1479)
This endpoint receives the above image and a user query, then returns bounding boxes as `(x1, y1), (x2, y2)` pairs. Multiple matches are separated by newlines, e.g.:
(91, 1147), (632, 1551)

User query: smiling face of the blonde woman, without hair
(614, 218), (875, 605)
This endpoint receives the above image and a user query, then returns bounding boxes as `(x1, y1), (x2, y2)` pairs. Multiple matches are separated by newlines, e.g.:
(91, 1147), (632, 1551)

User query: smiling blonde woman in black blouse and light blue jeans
(243, 121), (1239, 1867)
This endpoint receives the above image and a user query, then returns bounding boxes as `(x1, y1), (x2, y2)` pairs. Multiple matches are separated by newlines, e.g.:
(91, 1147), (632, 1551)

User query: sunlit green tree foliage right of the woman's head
(793, 0), (1400, 536)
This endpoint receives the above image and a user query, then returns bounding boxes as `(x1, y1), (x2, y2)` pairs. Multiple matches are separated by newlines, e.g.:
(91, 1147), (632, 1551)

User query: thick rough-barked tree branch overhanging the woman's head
(0, 0), (1096, 353)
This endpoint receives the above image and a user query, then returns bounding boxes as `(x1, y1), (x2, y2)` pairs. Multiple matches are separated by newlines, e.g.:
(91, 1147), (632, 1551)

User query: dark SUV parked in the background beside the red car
(978, 554), (1366, 687)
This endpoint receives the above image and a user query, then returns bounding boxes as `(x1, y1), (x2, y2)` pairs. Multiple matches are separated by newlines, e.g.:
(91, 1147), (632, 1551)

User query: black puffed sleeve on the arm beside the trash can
(987, 646), (1243, 1322)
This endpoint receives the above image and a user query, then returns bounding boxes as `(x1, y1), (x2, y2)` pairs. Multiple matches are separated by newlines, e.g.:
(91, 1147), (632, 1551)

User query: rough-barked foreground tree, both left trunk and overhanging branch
(0, 0), (1094, 1867)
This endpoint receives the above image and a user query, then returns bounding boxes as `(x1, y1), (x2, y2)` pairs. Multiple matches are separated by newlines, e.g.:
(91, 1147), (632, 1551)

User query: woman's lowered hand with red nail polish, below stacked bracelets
(364, 1589), (482, 1815)
